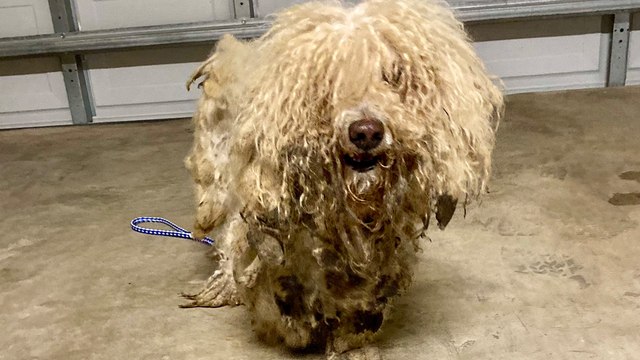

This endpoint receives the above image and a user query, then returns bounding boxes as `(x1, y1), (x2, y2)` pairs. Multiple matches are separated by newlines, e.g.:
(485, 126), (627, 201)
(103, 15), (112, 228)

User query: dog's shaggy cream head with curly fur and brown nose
(232, 0), (502, 233)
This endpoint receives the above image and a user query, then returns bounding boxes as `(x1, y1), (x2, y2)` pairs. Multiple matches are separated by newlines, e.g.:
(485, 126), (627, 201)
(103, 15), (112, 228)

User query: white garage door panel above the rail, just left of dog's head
(76, 0), (233, 30)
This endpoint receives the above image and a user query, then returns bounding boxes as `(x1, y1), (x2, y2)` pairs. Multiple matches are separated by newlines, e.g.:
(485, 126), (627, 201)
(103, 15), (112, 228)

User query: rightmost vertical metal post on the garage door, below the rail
(608, 11), (631, 86)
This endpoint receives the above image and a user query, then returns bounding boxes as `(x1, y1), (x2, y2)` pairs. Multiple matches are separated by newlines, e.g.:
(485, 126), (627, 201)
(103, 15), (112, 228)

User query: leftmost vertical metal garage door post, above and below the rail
(49, 0), (95, 124)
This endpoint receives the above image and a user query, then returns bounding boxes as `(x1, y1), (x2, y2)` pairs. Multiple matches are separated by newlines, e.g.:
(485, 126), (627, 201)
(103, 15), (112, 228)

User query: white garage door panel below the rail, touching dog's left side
(87, 44), (213, 122)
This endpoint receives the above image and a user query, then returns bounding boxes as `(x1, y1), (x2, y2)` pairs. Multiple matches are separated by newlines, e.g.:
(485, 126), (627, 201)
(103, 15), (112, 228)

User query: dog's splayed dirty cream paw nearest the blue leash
(180, 269), (242, 308)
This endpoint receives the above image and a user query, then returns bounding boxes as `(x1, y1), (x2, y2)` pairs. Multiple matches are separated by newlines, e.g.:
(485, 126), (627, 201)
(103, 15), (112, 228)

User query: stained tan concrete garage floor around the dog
(0, 88), (640, 360)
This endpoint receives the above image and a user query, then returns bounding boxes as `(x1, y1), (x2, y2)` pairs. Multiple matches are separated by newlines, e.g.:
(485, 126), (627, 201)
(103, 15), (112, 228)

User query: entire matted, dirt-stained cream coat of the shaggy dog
(186, 0), (502, 358)
